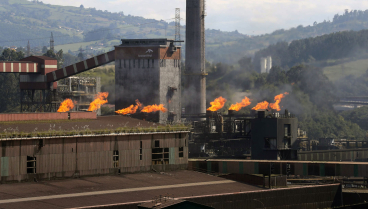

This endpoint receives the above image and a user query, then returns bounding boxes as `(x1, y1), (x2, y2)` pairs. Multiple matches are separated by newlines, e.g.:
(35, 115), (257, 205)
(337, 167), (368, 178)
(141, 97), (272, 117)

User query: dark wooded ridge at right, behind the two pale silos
(254, 30), (368, 68)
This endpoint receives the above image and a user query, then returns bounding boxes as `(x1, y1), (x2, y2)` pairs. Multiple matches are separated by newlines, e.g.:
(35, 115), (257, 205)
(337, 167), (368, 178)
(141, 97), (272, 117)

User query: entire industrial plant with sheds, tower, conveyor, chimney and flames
(0, 0), (368, 209)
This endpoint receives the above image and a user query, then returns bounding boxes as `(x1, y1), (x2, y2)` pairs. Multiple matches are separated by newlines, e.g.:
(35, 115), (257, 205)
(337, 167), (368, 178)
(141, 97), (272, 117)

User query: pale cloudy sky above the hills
(42, 0), (368, 35)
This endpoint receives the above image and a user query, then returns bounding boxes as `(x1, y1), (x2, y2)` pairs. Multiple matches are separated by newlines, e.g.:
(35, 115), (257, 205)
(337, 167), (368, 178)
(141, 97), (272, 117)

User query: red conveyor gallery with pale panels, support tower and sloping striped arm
(0, 50), (115, 112)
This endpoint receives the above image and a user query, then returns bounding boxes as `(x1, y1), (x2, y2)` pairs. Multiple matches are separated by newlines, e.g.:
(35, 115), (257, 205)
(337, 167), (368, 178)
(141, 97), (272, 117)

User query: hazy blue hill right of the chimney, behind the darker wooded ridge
(207, 10), (368, 66)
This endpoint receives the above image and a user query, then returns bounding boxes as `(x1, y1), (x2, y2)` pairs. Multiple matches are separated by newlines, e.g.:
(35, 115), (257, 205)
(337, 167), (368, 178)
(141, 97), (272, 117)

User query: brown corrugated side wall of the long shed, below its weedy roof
(0, 133), (188, 182)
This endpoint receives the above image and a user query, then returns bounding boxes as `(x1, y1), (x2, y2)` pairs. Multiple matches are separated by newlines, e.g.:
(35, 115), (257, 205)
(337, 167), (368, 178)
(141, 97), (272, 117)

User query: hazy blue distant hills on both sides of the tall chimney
(0, 0), (368, 61)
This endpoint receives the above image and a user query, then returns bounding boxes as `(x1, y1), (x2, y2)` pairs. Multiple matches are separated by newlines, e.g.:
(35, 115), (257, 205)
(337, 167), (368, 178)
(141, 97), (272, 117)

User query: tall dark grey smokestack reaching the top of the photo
(184, 0), (206, 114)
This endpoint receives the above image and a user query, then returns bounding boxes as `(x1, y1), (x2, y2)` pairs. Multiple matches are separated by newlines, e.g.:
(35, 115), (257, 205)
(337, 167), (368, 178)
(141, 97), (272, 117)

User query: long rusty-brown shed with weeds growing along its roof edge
(0, 116), (188, 183)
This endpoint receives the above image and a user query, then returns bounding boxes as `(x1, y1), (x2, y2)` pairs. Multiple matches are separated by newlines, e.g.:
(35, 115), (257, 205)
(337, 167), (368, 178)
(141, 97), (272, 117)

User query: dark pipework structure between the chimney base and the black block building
(182, 111), (254, 157)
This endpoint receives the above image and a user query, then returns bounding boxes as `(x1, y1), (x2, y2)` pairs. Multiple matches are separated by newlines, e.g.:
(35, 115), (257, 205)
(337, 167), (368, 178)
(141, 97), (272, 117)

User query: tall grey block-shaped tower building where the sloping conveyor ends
(115, 39), (181, 123)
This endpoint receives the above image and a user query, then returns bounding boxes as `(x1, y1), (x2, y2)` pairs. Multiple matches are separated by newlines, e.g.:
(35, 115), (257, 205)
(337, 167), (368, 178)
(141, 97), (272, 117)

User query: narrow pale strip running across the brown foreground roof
(0, 180), (234, 204)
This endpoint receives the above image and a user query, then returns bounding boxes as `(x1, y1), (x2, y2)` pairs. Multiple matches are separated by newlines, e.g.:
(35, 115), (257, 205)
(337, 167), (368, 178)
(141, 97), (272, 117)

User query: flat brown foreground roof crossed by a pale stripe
(0, 170), (263, 209)
